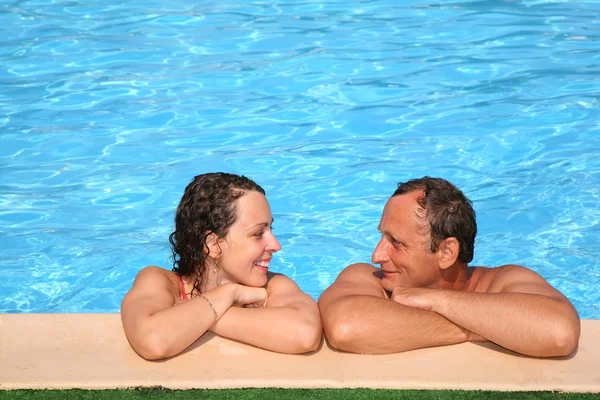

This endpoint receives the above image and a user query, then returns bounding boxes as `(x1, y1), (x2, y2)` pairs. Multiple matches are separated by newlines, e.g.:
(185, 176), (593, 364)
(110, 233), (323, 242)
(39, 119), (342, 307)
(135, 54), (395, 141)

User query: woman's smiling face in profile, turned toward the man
(217, 191), (281, 287)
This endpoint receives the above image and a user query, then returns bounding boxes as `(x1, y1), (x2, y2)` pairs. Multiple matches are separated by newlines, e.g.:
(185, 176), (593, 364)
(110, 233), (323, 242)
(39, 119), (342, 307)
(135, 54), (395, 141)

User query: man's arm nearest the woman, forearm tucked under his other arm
(319, 264), (467, 354)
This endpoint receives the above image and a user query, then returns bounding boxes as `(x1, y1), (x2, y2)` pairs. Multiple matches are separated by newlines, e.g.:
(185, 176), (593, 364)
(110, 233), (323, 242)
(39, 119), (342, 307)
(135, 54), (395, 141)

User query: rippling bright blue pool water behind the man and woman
(0, 0), (600, 318)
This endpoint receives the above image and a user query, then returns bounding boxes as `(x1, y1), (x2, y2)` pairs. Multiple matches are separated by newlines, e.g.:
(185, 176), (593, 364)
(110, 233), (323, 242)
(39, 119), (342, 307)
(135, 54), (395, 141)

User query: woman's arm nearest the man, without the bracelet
(210, 275), (323, 354)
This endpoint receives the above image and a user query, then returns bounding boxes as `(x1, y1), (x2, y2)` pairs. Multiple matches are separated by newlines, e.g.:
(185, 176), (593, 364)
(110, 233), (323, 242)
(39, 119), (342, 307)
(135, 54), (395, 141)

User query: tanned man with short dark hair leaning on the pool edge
(319, 177), (580, 357)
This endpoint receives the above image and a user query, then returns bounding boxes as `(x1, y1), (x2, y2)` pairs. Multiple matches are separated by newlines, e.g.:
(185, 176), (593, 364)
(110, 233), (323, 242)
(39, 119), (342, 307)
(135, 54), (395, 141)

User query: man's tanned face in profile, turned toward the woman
(371, 191), (440, 292)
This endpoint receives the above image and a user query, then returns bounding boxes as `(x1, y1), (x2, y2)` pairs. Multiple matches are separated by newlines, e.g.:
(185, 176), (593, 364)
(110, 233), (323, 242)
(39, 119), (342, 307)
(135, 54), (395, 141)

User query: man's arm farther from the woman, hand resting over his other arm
(393, 265), (580, 357)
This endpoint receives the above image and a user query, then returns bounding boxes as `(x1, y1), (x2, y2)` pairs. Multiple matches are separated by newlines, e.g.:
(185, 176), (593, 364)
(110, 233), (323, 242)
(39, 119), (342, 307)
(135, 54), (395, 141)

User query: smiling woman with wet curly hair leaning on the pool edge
(121, 173), (322, 360)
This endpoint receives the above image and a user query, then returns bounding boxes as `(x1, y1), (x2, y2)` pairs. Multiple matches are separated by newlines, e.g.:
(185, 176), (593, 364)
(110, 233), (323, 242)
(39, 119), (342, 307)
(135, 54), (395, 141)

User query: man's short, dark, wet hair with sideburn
(392, 176), (477, 263)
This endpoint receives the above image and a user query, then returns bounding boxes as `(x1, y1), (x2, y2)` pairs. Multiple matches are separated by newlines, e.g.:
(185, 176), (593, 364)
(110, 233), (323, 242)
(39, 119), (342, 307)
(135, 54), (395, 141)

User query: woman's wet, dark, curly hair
(169, 172), (265, 295)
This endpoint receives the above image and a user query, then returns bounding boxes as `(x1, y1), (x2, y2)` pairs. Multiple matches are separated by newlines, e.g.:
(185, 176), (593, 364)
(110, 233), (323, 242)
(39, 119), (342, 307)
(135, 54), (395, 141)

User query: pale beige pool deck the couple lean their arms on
(0, 314), (600, 393)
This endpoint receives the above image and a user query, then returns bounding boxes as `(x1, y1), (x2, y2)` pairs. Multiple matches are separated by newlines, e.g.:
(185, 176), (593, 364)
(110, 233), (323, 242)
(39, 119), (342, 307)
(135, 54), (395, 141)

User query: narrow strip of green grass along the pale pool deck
(0, 388), (600, 400)
